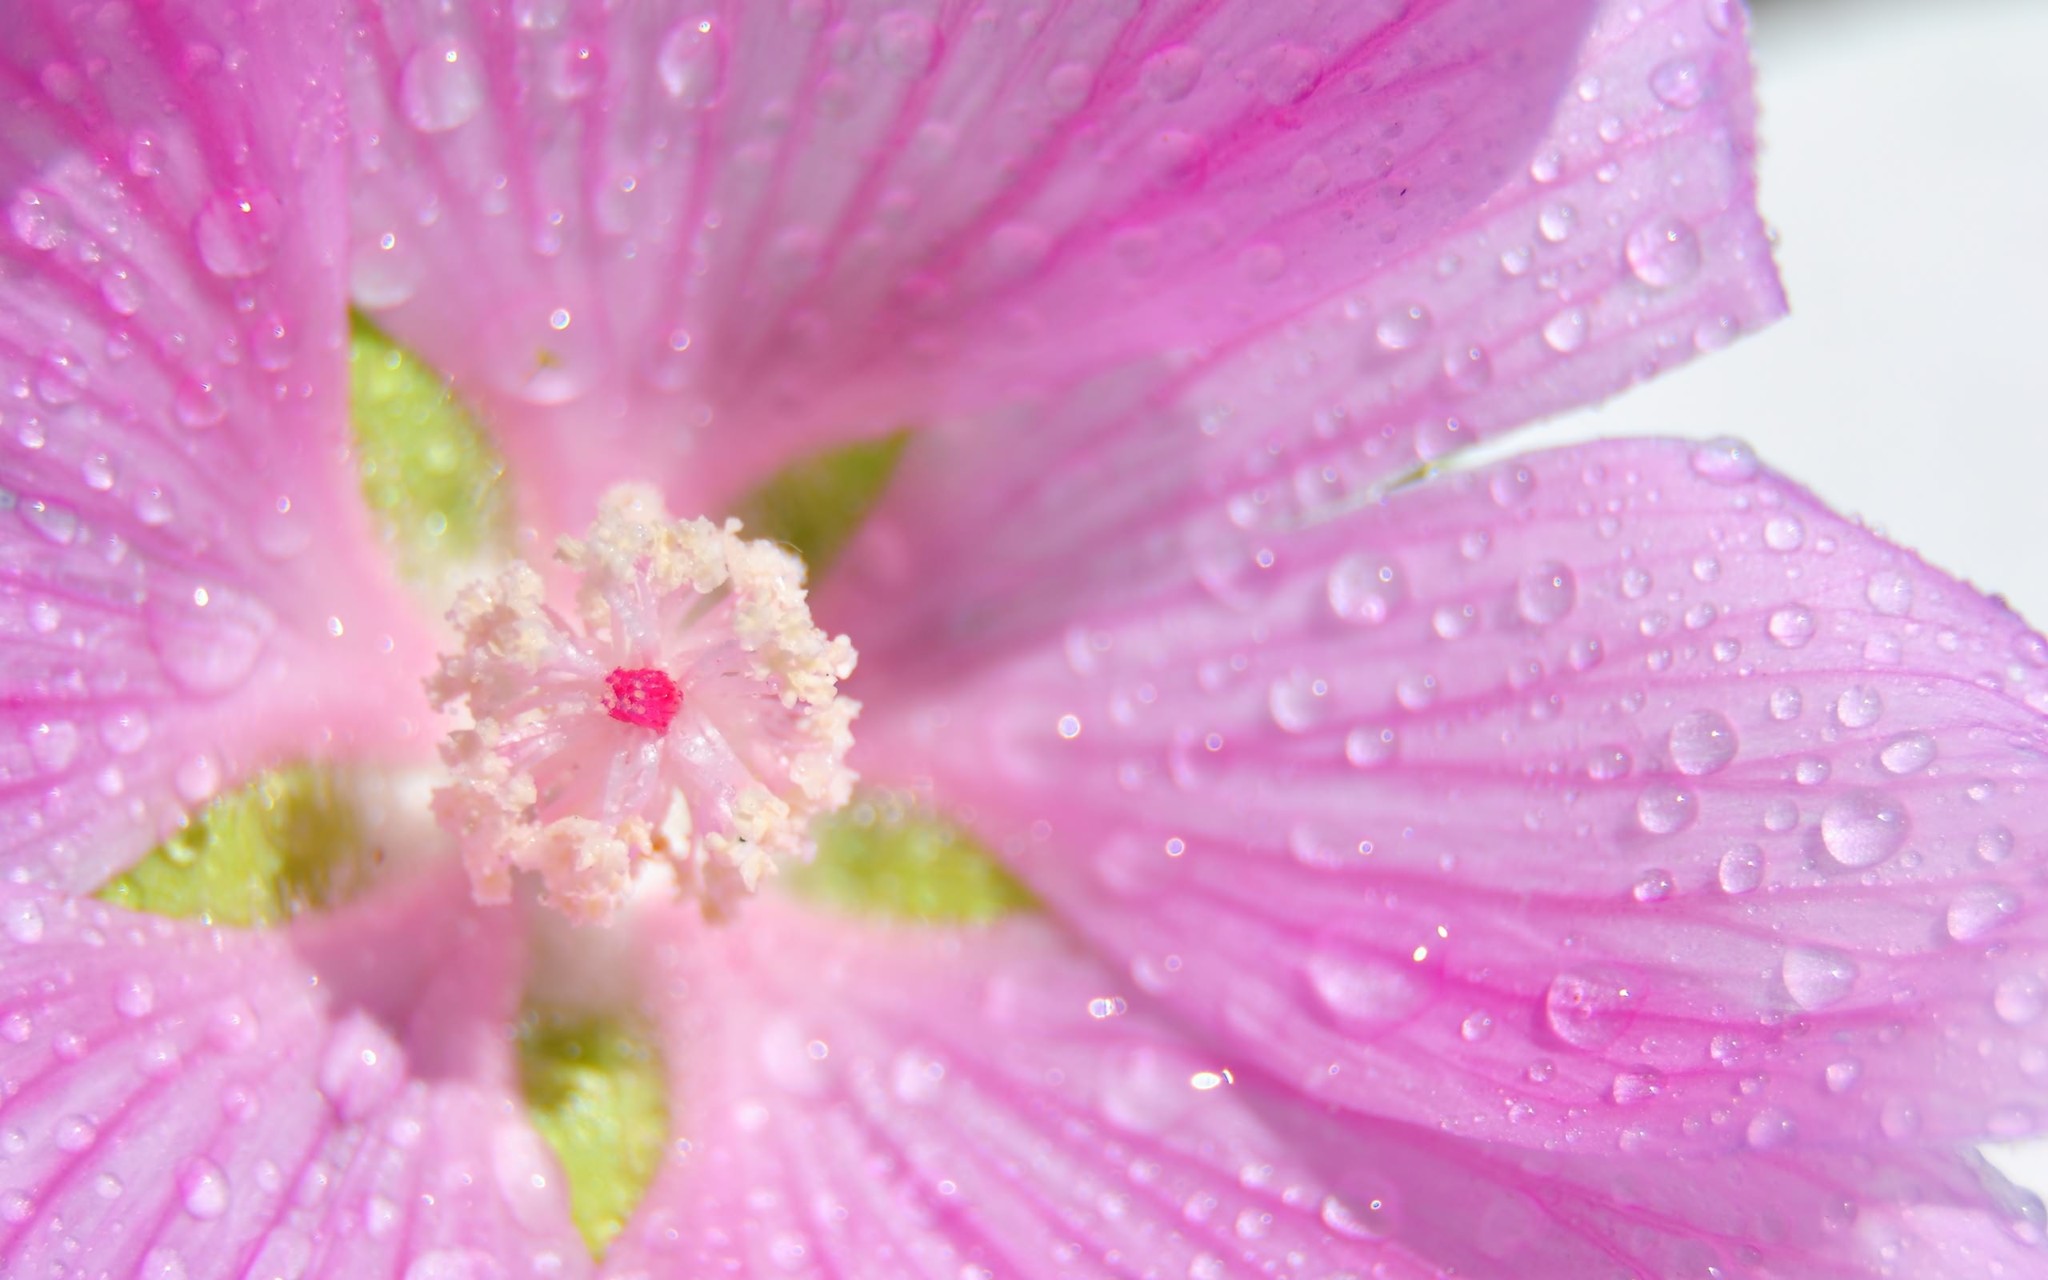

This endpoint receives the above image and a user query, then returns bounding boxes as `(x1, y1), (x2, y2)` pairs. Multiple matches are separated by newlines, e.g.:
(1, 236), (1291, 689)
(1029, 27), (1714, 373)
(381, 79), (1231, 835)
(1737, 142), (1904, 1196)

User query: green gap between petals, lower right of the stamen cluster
(788, 797), (1038, 924)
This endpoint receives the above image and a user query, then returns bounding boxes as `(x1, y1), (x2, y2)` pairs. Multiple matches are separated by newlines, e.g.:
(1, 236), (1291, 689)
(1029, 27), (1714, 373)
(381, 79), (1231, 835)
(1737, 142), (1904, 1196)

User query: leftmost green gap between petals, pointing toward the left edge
(98, 766), (375, 928)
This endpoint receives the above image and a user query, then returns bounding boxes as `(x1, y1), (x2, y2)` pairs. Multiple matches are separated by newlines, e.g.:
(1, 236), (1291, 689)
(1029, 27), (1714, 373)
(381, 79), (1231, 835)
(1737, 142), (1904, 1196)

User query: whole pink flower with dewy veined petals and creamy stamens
(0, 0), (2048, 1280)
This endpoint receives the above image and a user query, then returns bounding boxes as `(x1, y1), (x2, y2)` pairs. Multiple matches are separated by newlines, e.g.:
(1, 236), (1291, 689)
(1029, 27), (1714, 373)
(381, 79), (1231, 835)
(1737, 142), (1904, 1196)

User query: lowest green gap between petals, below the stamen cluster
(518, 1012), (668, 1257)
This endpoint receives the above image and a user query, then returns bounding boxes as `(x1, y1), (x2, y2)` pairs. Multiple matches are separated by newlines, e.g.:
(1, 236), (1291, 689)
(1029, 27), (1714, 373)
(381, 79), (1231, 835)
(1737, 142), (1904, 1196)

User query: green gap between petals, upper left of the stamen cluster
(348, 315), (508, 578)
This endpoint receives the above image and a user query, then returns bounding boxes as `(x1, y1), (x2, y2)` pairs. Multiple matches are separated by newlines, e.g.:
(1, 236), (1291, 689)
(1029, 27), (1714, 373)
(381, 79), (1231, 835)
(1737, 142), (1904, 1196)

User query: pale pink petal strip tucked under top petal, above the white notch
(819, 0), (1784, 670)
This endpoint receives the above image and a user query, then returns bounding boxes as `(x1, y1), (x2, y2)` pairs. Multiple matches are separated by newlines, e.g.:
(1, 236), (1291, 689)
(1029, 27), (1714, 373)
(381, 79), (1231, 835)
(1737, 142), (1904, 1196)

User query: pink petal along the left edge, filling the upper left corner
(0, 2), (436, 889)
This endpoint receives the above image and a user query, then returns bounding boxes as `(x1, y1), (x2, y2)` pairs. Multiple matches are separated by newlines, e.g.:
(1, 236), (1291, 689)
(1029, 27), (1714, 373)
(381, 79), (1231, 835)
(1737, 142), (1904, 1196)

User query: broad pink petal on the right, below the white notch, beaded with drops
(862, 442), (2048, 1151)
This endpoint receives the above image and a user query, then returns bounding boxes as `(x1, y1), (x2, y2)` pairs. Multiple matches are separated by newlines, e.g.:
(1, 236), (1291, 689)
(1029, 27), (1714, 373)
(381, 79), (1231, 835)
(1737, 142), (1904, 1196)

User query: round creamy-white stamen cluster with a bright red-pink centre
(428, 485), (860, 920)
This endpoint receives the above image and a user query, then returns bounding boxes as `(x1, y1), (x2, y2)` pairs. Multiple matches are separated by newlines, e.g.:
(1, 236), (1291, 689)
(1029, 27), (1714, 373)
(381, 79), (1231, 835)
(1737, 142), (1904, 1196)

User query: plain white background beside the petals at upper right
(1511, 0), (2048, 1192)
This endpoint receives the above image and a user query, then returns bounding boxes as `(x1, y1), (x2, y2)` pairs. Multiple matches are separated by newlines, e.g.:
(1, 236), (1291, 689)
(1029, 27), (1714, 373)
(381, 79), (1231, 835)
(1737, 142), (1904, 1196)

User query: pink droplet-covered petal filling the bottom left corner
(0, 877), (588, 1278)
